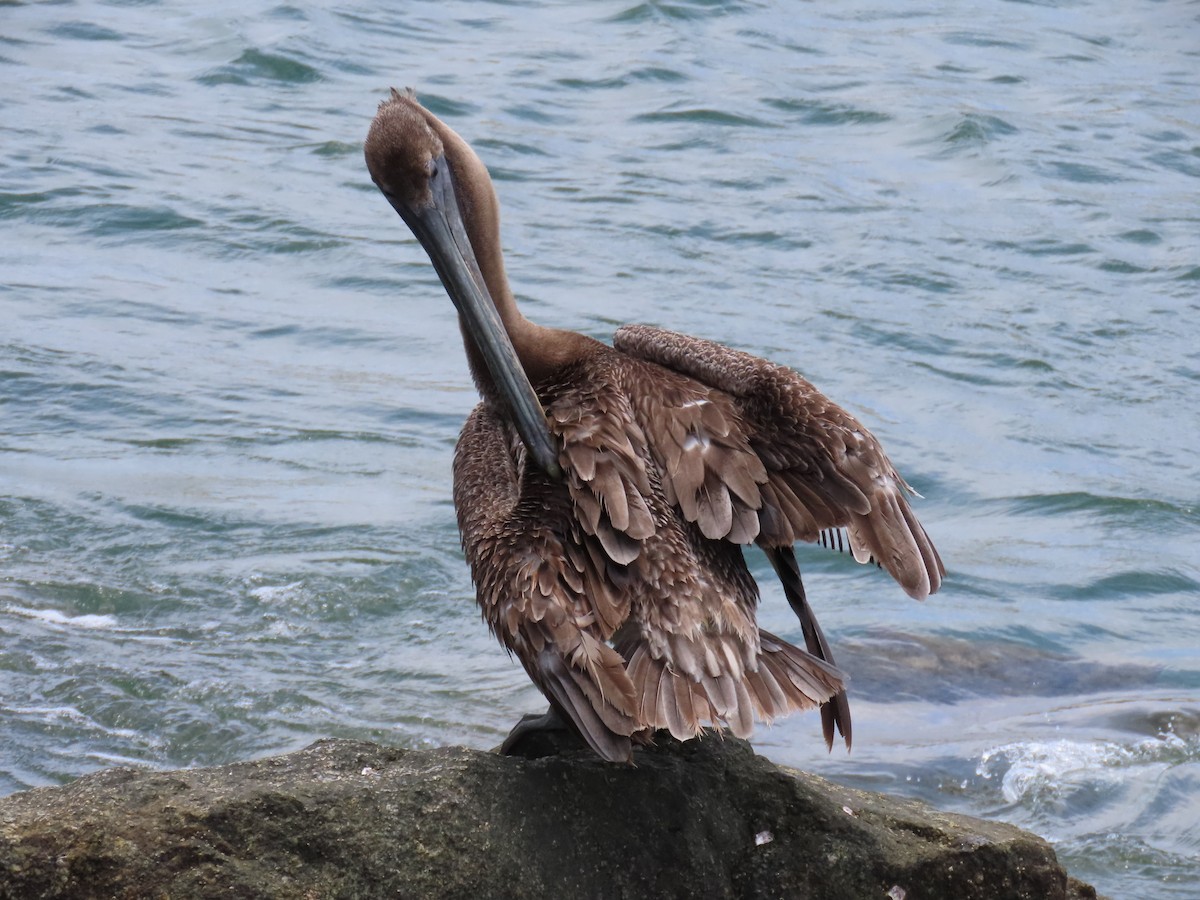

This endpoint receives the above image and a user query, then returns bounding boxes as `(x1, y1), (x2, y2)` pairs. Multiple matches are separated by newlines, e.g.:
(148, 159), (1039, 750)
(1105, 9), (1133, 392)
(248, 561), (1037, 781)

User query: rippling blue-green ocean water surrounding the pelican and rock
(0, 0), (1200, 899)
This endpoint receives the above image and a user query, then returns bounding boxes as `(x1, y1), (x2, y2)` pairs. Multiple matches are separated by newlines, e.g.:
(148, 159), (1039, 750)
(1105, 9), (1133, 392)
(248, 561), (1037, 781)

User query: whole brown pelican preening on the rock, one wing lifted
(365, 90), (944, 762)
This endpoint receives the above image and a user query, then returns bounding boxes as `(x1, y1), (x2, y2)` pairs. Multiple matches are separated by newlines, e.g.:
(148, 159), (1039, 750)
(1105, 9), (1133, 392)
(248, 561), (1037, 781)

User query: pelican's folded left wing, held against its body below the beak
(455, 404), (640, 761)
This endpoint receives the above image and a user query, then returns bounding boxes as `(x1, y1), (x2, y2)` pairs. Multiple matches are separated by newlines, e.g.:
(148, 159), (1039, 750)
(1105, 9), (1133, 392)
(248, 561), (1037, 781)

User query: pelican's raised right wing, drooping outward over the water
(613, 325), (944, 599)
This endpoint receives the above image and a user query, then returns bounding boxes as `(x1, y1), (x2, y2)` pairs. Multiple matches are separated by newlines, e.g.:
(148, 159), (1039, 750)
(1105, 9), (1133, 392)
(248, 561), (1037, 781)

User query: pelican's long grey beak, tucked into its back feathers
(384, 157), (563, 479)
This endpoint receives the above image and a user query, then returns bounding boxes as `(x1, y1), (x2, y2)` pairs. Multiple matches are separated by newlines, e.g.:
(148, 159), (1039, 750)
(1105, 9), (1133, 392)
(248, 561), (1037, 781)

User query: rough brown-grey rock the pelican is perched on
(0, 737), (1096, 900)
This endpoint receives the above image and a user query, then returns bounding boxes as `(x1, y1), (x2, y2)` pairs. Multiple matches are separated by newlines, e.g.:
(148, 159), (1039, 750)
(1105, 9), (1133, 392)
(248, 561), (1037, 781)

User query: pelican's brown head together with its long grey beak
(364, 89), (562, 478)
